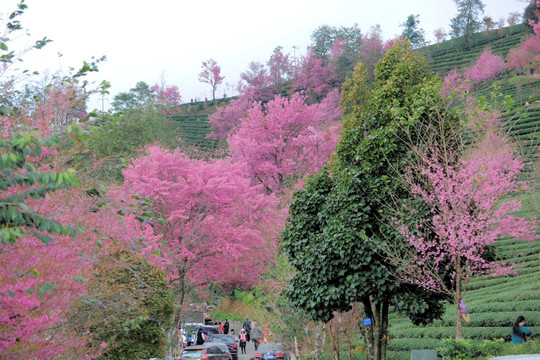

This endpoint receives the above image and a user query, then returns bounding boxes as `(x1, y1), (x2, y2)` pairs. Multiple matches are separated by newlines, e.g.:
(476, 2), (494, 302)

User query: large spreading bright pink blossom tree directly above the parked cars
(123, 146), (283, 305)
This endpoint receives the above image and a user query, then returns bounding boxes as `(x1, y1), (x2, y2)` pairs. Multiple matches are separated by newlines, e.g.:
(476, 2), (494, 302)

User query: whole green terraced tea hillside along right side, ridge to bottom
(388, 25), (540, 360)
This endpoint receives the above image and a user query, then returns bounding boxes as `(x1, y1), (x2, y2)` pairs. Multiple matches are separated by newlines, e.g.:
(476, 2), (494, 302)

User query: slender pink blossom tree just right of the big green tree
(399, 113), (538, 340)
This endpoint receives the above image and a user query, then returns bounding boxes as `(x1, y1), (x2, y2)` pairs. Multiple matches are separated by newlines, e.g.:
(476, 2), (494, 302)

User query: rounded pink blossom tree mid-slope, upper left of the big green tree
(228, 93), (337, 193)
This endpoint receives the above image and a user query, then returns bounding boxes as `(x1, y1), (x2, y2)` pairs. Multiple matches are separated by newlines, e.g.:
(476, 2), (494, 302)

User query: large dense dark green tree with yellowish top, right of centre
(282, 41), (457, 360)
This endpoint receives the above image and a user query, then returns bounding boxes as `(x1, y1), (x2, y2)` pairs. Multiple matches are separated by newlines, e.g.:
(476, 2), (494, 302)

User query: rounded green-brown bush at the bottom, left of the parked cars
(71, 250), (174, 360)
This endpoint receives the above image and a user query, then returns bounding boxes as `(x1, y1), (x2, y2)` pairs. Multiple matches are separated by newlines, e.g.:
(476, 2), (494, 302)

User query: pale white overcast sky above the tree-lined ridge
(0, 0), (527, 109)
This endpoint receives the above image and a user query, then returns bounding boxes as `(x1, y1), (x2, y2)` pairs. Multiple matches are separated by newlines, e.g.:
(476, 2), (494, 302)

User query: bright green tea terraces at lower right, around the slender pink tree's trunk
(388, 195), (540, 360)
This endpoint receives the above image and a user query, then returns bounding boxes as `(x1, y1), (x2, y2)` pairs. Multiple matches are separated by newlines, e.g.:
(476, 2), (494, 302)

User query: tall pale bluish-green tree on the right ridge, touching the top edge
(450, 0), (485, 46)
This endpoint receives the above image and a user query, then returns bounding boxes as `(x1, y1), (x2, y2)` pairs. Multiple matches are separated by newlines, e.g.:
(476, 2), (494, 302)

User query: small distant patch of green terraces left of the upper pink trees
(170, 115), (219, 151)
